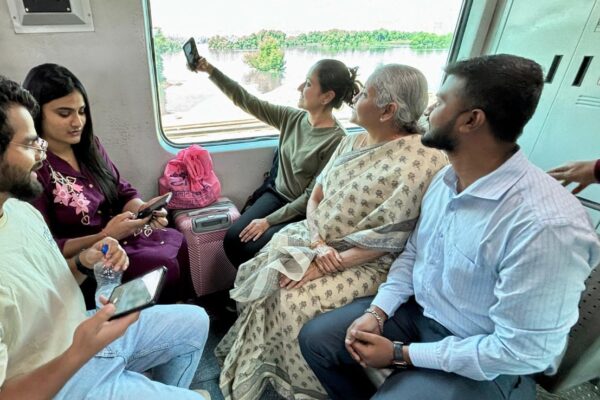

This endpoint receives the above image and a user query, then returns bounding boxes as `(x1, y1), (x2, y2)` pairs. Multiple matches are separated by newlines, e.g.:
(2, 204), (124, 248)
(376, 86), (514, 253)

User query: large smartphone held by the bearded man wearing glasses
(108, 267), (167, 319)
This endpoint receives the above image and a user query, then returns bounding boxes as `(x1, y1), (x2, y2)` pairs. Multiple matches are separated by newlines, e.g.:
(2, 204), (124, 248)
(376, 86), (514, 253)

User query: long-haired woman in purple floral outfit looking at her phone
(23, 64), (192, 302)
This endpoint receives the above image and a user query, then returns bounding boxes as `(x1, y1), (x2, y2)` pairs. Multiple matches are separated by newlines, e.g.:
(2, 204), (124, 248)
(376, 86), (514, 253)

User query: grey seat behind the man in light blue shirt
(537, 266), (600, 392)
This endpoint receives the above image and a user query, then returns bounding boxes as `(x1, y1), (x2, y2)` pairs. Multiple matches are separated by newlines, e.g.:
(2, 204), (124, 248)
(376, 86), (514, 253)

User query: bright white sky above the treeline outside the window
(150, 0), (462, 37)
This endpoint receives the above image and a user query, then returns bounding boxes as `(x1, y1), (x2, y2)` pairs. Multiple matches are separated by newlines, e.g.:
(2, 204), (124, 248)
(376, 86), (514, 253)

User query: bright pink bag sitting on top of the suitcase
(158, 144), (221, 209)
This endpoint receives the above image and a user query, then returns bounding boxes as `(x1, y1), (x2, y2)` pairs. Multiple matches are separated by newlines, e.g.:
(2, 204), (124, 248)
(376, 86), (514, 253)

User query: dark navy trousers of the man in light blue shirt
(298, 297), (535, 400)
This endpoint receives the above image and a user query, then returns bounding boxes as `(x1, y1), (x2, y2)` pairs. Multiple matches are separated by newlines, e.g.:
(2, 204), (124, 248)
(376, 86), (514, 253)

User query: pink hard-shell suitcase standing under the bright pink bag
(174, 197), (240, 296)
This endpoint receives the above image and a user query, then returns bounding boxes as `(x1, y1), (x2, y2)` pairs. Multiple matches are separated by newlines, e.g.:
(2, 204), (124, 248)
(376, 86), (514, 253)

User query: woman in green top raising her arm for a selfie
(190, 57), (359, 267)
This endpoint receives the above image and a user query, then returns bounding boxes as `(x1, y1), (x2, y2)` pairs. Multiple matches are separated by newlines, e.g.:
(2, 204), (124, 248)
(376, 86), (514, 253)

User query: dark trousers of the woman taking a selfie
(223, 190), (304, 268)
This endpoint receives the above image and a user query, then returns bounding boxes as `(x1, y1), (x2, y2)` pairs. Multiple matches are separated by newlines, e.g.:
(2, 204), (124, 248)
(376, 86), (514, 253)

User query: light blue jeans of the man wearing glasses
(55, 305), (209, 400)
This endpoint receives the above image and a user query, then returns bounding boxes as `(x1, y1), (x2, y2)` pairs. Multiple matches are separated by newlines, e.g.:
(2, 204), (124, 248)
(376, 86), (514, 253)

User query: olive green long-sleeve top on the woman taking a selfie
(210, 68), (346, 226)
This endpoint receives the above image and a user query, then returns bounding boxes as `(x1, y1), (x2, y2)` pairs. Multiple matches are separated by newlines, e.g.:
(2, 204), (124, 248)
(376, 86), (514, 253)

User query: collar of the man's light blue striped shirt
(443, 150), (529, 200)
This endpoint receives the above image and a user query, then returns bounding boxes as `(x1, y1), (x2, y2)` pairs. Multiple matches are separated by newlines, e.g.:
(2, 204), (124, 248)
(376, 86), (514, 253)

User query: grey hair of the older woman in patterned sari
(366, 64), (428, 133)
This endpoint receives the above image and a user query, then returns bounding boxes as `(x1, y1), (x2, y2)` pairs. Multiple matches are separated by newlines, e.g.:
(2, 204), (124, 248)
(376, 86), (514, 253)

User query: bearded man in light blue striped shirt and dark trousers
(299, 55), (600, 400)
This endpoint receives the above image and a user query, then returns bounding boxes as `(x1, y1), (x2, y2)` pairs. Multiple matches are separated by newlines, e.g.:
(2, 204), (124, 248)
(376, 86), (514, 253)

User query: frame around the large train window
(142, 0), (478, 153)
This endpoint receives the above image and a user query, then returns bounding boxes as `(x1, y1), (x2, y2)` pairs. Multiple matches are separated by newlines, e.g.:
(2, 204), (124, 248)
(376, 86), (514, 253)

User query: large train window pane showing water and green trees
(146, 0), (469, 144)
